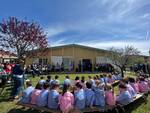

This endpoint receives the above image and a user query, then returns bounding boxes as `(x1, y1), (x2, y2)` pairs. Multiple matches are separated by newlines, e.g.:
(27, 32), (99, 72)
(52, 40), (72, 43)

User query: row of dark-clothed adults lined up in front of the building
(25, 63), (114, 76)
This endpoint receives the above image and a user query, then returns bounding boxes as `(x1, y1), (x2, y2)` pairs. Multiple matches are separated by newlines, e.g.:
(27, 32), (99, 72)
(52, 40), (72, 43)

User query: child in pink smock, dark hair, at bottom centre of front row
(59, 84), (74, 113)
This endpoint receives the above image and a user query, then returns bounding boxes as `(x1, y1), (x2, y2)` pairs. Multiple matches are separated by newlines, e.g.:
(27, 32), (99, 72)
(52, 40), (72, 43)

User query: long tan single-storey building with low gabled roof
(26, 44), (115, 71)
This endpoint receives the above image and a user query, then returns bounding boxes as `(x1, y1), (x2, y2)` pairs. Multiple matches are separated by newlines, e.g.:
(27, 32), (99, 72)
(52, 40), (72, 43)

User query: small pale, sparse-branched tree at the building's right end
(109, 46), (140, 77)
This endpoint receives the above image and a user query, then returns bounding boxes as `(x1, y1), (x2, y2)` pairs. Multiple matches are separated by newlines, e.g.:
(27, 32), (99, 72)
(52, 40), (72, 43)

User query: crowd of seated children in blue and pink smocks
(21, 74), (150, 113)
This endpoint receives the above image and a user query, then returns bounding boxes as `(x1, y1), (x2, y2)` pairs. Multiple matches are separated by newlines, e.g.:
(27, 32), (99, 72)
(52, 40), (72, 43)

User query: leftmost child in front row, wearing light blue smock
(21, 80), (34, 103)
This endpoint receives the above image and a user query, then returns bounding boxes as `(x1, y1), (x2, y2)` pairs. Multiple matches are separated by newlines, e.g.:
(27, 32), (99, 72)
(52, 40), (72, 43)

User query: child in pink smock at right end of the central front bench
(105, 84), (116, 106)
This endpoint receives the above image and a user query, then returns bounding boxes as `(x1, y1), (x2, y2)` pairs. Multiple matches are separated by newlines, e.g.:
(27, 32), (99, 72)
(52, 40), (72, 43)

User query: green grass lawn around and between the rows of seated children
(0, 73), (150, 113)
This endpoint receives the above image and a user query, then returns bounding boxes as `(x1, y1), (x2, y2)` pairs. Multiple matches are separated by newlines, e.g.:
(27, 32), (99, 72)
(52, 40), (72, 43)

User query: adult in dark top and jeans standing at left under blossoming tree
(11, 60), (24, 99)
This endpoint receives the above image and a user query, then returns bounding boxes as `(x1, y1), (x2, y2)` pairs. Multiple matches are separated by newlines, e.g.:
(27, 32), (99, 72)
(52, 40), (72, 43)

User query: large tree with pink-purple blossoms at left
(0, 17), (48, 59)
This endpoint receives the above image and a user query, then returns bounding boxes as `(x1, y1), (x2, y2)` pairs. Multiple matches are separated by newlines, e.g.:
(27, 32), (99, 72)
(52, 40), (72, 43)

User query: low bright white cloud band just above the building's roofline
(48, 39), (150, 55)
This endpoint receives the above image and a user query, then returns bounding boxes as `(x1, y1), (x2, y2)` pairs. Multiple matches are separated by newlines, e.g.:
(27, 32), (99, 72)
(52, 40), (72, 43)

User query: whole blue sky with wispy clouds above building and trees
(0, 0), (150, 55)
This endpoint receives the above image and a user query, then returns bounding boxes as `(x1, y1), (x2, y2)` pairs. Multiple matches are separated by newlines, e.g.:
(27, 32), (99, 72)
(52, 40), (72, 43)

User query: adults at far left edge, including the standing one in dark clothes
(0, 60), (24, 98)
